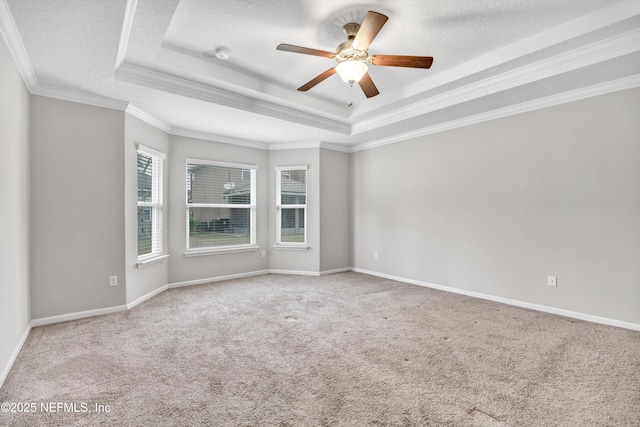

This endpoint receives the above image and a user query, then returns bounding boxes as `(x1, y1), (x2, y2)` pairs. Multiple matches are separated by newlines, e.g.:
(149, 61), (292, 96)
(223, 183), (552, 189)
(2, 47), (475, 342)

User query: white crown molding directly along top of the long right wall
(351, 75), (640, 152)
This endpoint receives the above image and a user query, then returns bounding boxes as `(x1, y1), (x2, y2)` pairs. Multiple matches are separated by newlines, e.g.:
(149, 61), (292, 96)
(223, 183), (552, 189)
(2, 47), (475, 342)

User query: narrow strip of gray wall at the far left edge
(0, 37), (30, 385)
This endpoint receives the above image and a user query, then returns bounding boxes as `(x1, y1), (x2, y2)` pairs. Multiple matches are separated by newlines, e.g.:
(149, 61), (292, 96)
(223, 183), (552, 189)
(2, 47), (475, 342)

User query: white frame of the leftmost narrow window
(136, 144), (168, 268)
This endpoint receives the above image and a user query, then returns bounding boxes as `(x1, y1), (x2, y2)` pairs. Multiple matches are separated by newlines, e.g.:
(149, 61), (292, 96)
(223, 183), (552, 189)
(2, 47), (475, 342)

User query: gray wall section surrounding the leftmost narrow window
(124, 114), (169, 303)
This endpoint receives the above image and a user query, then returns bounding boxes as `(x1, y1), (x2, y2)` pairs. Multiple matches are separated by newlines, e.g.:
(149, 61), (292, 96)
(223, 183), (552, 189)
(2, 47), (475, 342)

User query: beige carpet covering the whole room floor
(0, 273), (640, 426)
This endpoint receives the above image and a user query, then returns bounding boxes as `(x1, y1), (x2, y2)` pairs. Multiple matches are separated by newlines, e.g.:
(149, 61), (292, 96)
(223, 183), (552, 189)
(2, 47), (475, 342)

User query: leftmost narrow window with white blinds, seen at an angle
(137, 145), (165, 259)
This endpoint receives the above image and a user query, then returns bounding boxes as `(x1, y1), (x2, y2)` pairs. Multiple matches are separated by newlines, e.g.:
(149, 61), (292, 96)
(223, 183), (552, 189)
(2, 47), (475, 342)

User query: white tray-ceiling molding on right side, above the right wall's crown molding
(352, 30), (640, 135)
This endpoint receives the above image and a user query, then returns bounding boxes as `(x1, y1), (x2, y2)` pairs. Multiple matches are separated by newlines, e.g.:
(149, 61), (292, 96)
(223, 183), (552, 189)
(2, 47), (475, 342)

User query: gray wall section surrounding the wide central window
(168, 135), (269, 283)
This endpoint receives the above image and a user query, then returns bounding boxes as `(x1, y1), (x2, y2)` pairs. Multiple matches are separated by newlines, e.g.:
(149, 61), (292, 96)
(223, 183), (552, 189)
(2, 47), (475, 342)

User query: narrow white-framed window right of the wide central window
(276, 166), (307, 247)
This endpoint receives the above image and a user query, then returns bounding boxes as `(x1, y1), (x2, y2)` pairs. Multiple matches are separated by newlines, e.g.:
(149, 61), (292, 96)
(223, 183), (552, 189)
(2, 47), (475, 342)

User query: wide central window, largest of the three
(185, 159), (257, 255)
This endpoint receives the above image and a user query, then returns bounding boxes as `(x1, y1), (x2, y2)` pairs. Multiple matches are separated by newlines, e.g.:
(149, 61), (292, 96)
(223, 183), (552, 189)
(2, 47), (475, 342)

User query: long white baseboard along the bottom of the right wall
(353, 268), (640, 331)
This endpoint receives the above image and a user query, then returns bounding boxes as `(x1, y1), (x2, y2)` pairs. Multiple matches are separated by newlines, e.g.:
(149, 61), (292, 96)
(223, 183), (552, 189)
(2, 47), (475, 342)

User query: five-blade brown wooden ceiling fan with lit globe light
(277, 11), (433, 98)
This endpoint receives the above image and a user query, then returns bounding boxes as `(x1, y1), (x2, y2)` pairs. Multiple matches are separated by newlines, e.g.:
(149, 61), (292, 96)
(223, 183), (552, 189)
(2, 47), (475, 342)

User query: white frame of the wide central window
(184, 158), (258, 257)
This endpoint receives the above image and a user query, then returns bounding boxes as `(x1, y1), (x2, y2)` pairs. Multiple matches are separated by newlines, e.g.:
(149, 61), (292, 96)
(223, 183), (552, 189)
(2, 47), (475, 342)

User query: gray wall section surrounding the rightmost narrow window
(268, 148), (320, 273)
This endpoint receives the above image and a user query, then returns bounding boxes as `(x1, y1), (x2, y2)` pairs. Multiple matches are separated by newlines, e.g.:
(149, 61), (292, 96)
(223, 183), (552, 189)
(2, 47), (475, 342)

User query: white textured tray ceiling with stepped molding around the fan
(0, 0), (640, 151)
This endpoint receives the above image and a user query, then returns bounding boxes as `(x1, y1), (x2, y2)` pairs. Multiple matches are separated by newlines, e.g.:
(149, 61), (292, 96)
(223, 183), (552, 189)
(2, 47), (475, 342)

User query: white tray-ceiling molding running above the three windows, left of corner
(115, 61), (351, 135)
